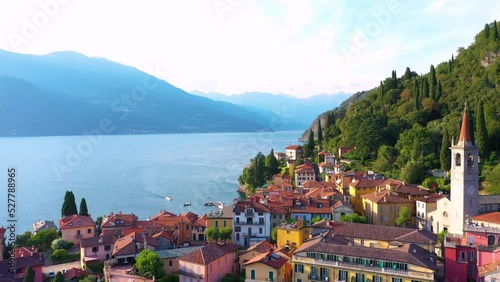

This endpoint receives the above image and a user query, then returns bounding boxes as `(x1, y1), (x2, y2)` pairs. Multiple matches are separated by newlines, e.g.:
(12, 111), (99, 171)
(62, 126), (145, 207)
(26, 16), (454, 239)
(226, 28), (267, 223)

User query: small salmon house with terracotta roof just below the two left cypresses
(59, 214), (95, 245)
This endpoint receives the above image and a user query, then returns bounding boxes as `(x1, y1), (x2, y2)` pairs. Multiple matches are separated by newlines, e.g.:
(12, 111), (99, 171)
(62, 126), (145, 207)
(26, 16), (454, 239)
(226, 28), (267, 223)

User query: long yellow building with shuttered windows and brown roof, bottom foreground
(292, 232), (437, 282)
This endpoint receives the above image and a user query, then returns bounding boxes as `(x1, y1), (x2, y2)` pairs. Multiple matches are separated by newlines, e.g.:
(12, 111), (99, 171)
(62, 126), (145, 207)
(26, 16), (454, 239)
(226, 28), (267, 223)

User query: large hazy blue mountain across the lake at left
(0, 50), (282, 136)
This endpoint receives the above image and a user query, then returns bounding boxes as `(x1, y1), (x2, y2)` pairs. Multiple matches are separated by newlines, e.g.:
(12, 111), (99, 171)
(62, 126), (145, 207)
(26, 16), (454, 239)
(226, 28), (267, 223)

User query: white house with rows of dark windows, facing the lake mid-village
(233, 199), (271, 247)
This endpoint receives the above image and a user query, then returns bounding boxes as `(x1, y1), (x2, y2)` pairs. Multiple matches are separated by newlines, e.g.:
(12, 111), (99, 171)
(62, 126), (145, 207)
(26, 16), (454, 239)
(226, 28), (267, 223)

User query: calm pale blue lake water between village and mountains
(0, 131), (302, 234)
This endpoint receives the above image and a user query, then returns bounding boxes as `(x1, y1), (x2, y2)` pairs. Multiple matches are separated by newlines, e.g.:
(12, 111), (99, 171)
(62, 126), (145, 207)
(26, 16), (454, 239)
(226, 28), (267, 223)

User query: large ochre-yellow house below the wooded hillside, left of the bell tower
(361, 189), (416, 226)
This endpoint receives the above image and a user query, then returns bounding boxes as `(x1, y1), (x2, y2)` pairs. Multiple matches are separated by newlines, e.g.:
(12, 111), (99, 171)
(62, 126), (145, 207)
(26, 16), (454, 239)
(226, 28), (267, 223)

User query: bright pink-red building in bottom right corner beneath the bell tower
(444, 212), (500, 281)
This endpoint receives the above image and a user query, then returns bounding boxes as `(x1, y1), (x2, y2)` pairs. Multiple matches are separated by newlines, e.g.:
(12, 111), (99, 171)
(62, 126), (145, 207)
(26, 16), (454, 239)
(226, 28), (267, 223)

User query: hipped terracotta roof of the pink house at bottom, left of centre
(179, 243), (239, 265)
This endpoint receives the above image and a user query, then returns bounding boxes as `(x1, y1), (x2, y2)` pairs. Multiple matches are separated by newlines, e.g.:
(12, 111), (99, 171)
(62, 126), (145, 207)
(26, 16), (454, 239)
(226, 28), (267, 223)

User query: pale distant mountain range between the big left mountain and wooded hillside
(191, 90), (350, 129)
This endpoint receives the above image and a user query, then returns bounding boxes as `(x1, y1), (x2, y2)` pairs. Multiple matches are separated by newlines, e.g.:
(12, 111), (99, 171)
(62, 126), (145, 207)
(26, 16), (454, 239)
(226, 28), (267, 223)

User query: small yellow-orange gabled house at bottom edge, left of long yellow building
(245, 253), (292, 282)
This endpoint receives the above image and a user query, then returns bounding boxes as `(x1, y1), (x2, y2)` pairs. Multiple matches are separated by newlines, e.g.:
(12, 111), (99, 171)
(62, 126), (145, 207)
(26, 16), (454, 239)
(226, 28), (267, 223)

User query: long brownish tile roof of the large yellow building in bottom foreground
(294, 232), (437, 270)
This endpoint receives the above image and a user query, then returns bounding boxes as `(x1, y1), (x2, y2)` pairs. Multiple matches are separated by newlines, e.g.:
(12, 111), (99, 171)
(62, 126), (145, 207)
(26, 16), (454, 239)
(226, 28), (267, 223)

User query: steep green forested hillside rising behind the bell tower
(310, 21), (500, 193)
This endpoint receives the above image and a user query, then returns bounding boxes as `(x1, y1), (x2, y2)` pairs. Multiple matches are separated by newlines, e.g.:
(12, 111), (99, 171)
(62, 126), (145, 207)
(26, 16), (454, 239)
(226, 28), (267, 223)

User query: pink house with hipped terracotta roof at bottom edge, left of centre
(179, 243), (239, 282)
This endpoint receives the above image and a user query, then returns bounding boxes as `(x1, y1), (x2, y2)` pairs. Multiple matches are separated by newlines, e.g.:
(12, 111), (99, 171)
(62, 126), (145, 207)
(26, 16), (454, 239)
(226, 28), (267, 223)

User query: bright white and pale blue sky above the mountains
(0, 0), (500, 98)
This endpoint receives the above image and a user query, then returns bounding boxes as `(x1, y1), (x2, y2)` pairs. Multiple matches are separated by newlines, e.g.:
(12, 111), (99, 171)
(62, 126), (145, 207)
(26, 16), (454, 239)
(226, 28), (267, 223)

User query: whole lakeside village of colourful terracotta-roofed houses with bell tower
(0, 108), (500, 282)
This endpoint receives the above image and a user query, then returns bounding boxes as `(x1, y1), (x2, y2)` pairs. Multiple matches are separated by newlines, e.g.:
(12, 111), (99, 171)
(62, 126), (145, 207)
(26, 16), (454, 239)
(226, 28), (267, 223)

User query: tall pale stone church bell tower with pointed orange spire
(449, 107), (479, 234)
